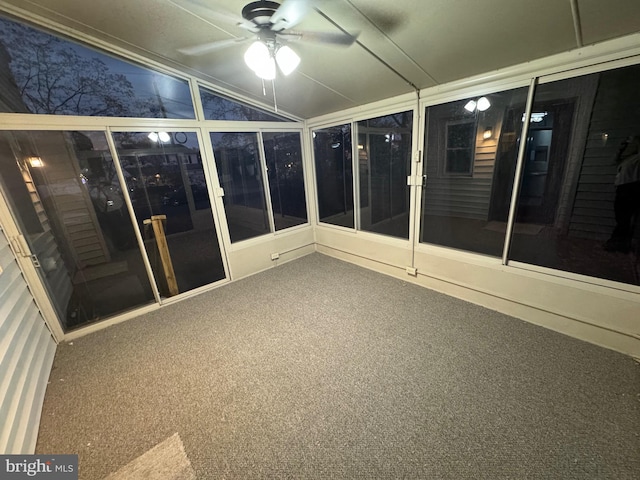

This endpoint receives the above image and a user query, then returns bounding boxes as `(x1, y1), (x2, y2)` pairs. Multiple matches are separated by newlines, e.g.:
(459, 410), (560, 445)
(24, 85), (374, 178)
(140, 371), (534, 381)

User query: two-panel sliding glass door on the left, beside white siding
(0, 127), (227, 331)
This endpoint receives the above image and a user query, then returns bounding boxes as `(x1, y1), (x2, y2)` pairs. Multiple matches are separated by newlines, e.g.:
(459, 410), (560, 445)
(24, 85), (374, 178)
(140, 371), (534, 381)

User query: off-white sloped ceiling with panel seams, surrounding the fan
(0, 0), (640, 118)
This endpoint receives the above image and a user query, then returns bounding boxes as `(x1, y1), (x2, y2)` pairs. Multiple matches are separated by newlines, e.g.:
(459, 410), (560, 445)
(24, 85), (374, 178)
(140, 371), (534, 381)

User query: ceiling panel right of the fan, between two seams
(350, 0), (576, 86)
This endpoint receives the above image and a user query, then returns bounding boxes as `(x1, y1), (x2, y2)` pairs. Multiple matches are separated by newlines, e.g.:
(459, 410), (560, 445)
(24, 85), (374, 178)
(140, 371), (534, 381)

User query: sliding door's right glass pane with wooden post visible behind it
(113, 132), (226, 297)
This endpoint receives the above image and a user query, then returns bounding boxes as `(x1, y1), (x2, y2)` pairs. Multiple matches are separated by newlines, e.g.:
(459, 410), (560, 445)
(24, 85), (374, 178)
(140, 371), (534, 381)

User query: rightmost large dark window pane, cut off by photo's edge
(509, 65), (640, 285)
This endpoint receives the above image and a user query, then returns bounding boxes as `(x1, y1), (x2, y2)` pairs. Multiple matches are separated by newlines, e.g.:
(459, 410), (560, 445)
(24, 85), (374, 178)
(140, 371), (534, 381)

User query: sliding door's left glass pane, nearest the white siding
(0, 131), (154, 330)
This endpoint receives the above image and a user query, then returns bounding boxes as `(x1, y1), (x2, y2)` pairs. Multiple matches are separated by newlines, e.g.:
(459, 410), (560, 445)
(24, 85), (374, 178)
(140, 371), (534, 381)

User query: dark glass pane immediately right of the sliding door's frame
(211, 132), (271, 242)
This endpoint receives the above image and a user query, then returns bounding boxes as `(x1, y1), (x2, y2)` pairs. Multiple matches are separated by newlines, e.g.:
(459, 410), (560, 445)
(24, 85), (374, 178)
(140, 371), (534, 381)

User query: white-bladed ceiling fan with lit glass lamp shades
(169, 0), (357, 80)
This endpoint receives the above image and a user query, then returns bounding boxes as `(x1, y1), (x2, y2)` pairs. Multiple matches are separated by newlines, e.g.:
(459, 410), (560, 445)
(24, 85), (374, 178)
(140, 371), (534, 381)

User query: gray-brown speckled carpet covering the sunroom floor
(37, 254), (640, 480)
